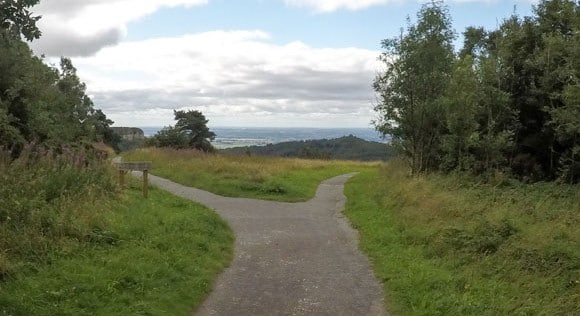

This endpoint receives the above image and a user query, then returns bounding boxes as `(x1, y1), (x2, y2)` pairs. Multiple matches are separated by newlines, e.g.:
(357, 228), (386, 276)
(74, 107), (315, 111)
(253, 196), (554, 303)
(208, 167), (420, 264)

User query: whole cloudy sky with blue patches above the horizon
(31, 0), (534, 128)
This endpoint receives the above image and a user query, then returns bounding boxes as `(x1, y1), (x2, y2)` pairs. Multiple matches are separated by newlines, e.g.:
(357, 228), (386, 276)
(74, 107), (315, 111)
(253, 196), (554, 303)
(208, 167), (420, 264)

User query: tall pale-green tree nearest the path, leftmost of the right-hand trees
(373, 1), (455, 173)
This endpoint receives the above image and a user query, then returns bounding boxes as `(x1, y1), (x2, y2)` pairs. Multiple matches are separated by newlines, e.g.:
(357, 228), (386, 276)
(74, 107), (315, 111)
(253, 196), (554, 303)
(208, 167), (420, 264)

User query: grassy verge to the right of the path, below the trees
(346, 164), (580, 315)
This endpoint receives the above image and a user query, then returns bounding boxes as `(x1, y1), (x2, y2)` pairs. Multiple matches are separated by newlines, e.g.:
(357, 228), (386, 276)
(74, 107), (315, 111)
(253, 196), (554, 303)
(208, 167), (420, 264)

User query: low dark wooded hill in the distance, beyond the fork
(220, 135), (394, 161)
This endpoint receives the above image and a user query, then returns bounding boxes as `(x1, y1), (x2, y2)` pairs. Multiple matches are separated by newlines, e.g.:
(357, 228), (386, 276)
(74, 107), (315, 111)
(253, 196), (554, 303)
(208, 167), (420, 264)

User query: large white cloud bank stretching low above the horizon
(73, 31), (379, 126)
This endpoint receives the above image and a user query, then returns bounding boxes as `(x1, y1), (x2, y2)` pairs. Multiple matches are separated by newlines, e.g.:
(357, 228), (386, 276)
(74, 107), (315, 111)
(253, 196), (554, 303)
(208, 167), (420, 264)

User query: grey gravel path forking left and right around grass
(135, 174), (386, 316)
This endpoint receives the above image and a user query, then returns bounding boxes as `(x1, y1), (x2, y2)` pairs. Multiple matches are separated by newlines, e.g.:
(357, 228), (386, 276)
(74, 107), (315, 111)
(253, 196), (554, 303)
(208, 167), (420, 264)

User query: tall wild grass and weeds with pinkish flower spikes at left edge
(0, 146), (116, 281)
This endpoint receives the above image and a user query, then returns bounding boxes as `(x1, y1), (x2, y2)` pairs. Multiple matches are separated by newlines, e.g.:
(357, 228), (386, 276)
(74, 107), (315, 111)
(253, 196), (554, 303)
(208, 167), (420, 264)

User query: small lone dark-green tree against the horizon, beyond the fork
(148, 111), (215, 152)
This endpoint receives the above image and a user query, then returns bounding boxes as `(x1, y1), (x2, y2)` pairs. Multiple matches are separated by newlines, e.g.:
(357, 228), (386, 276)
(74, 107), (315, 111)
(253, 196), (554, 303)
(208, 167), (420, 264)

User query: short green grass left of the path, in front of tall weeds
(0, 167), (233, 316)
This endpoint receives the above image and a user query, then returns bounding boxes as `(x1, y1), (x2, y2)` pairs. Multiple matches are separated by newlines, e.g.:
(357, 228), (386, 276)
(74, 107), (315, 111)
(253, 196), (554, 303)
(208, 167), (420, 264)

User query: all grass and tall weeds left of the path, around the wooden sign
(0, 149), (233, 316)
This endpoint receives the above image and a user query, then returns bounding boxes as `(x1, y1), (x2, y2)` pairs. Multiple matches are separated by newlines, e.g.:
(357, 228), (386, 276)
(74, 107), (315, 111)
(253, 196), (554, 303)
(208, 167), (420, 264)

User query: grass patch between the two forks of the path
(124, 148), (376, 202)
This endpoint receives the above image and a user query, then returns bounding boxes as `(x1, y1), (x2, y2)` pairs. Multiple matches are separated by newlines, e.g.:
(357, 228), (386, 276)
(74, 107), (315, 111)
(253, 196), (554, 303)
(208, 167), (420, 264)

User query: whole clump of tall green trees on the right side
(374, 0), (580, 182)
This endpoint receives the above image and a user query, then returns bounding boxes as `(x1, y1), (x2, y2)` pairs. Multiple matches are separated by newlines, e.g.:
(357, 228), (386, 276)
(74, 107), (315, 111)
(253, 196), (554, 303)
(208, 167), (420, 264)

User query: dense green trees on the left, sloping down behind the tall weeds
(0, 33), (116, 156)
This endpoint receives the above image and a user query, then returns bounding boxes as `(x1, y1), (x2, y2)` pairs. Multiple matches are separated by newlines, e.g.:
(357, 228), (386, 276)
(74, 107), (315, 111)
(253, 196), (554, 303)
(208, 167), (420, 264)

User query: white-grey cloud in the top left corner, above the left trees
(31, 0), (208, 56)
